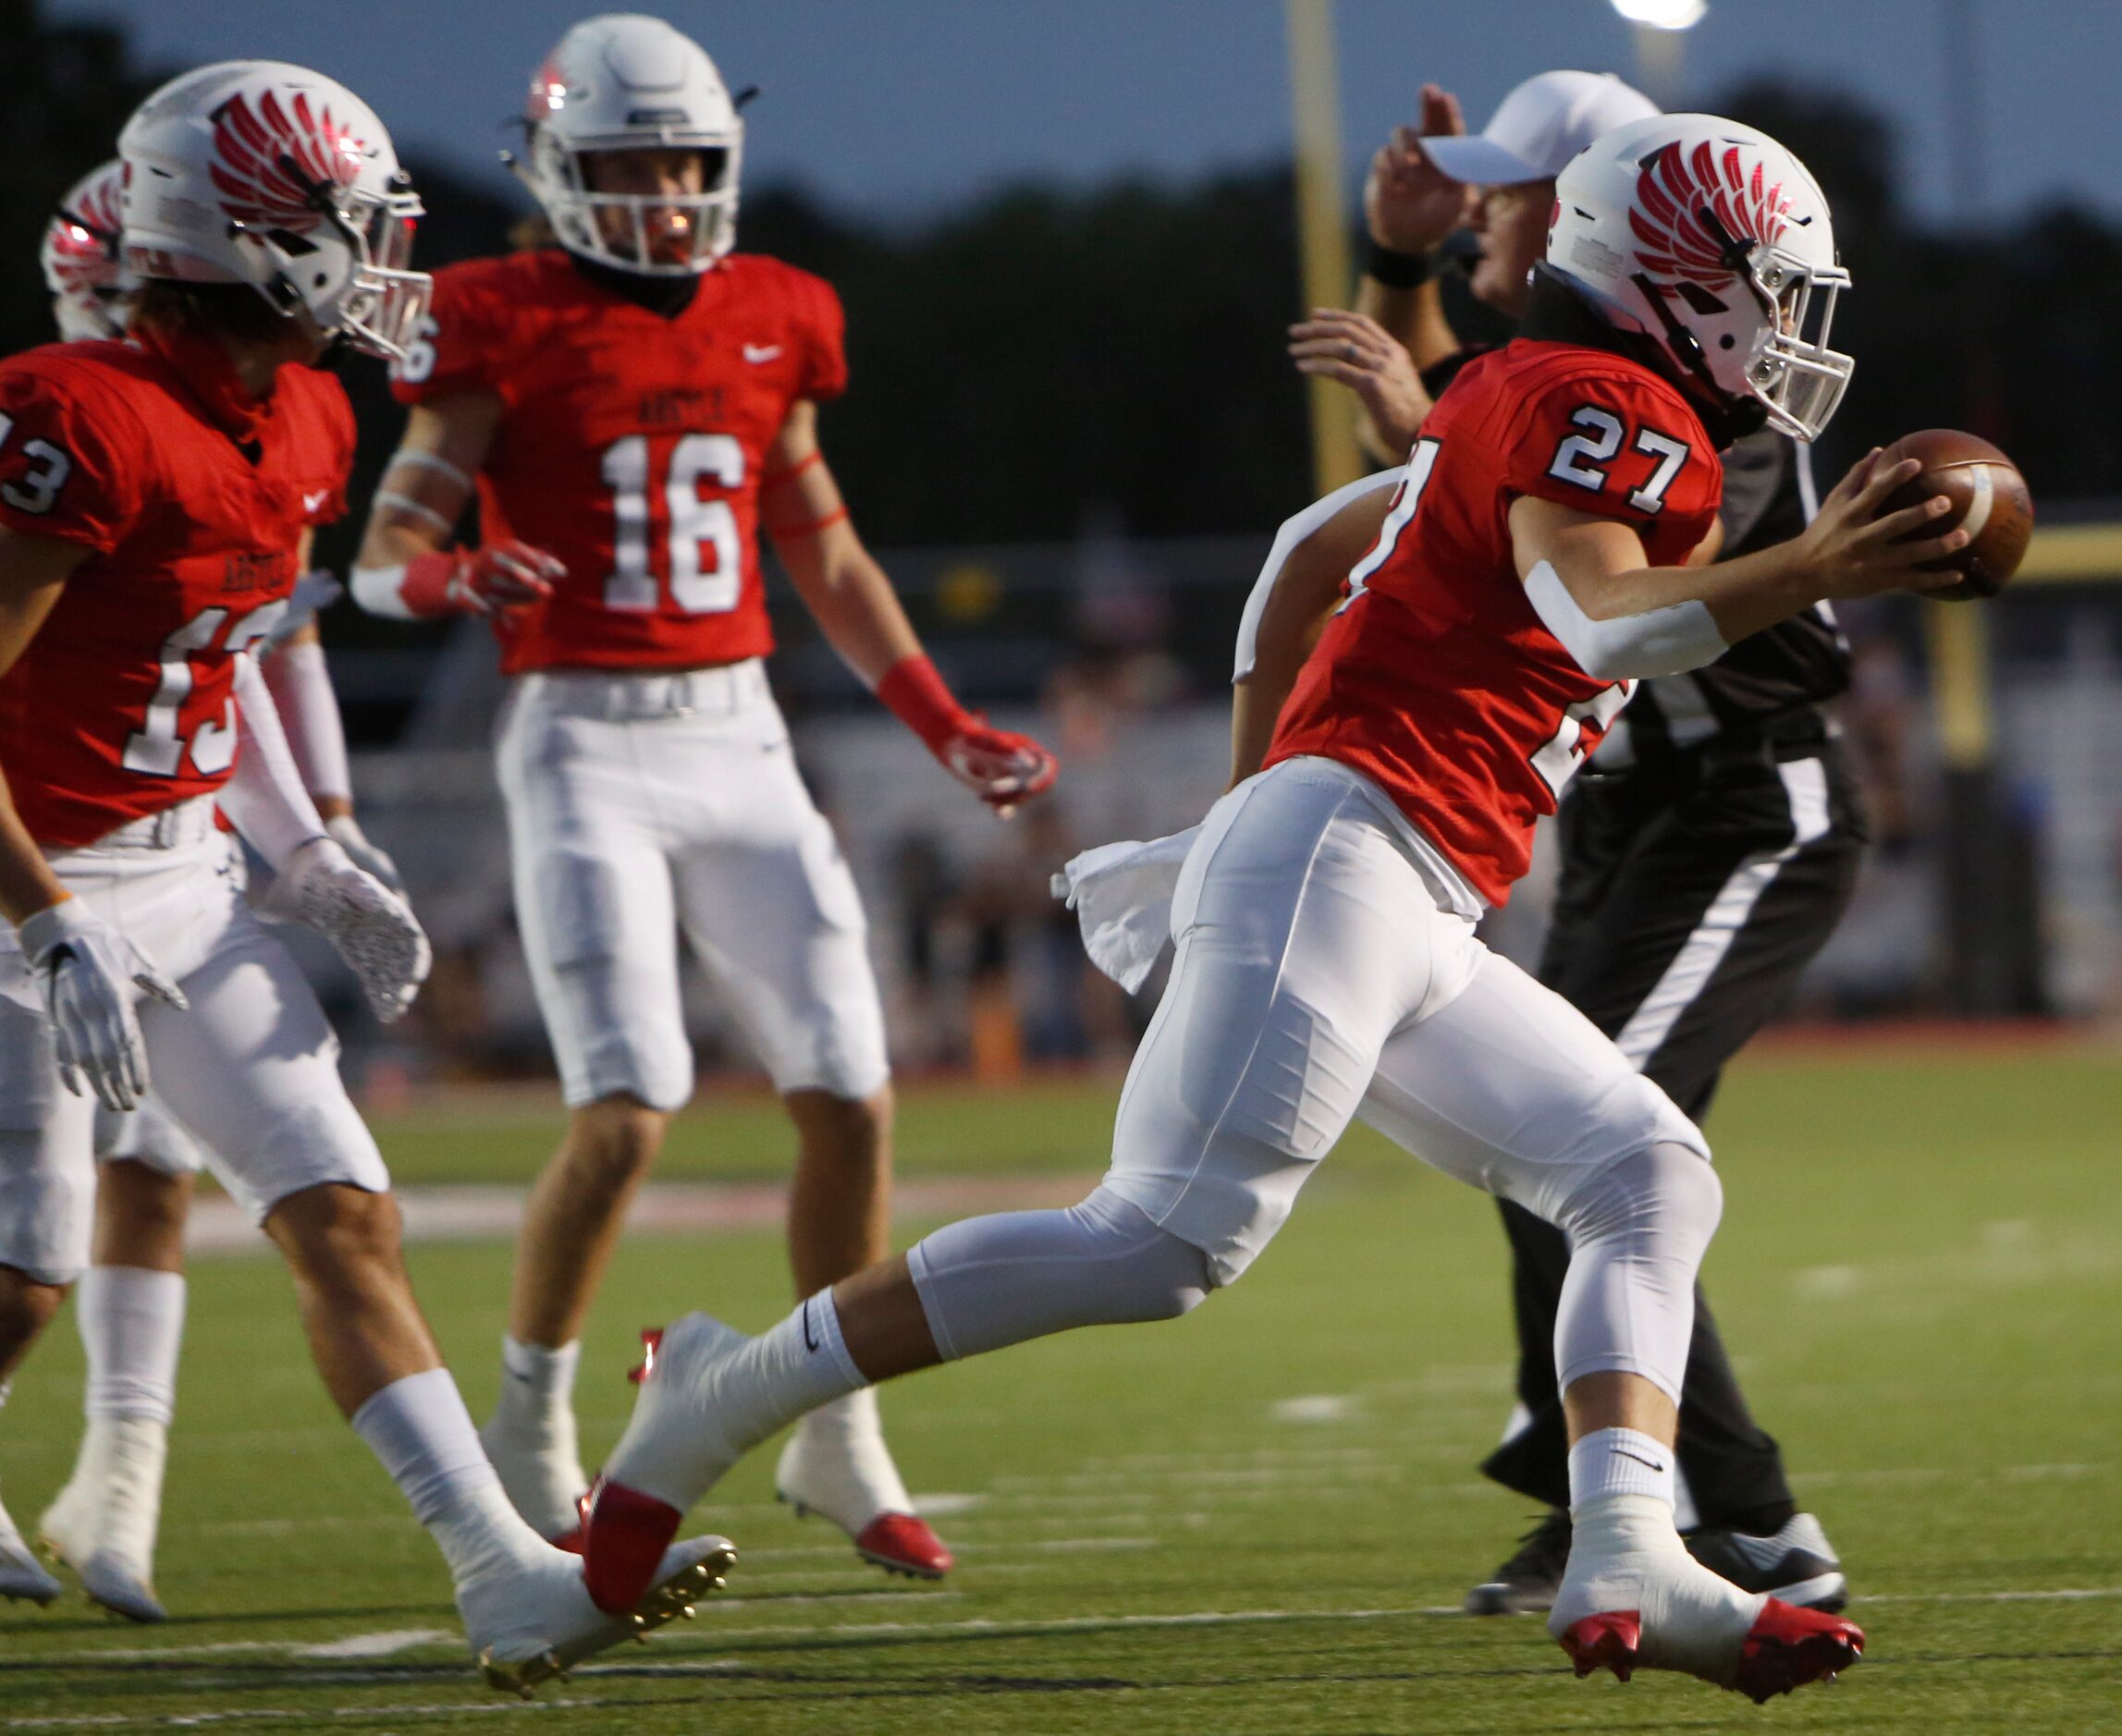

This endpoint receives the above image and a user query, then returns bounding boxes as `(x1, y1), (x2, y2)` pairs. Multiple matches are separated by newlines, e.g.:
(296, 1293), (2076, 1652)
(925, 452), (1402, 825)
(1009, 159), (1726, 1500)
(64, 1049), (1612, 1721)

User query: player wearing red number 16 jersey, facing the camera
(352, 17), (1055, 1577)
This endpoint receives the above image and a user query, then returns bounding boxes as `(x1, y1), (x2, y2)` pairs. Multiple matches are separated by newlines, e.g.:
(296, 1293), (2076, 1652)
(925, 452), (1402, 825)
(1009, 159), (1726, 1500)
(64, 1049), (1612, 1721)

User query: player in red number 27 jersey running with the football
(583, 115), (1965, 1698)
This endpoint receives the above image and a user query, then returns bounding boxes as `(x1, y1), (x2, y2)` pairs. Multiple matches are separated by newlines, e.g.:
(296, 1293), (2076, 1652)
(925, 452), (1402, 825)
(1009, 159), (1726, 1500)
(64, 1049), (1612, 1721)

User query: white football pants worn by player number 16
(498, 660), (889, 1110)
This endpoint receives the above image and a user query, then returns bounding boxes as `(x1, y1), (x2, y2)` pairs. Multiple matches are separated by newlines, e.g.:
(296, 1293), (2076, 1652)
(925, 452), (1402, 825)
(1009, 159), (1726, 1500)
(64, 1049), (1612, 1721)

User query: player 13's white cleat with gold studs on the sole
(456, 1536), (736, 1700)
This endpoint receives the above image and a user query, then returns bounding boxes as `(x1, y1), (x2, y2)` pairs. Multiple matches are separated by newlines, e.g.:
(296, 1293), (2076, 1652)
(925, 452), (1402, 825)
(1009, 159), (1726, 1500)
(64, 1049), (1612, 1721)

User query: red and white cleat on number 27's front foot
(1547, 1497), (1863, 1705)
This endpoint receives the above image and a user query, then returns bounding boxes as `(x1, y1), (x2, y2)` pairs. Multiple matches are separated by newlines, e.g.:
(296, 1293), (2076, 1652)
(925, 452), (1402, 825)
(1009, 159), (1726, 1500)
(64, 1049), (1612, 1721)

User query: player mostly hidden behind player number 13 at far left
(21, 157), (401, 1621)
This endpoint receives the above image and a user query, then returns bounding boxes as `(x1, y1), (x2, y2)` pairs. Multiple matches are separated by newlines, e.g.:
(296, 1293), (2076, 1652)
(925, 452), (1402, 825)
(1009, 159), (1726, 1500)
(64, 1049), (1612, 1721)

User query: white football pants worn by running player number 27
(911, 760), (1721, 1397)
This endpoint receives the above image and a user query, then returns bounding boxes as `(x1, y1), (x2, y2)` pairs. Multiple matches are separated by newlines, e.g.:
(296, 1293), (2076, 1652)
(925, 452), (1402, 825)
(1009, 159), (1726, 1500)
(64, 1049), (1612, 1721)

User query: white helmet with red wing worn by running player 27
(1547, 115), (1855, 439)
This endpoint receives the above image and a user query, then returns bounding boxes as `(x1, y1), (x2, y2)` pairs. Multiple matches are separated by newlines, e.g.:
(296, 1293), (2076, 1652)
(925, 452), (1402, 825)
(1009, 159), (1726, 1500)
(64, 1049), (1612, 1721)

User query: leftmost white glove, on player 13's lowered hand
(17, 898), (189, 1110)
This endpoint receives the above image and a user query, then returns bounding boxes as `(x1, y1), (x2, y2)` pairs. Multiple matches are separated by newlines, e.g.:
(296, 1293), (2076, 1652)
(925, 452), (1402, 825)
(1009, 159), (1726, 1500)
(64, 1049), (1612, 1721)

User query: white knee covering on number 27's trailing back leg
(906, 1186), (1214, 1361)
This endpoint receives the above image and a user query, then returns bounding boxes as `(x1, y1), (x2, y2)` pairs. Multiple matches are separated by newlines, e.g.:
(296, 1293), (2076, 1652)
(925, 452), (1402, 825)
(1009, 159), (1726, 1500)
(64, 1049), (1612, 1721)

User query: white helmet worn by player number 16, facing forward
(501, 13), (745, 278)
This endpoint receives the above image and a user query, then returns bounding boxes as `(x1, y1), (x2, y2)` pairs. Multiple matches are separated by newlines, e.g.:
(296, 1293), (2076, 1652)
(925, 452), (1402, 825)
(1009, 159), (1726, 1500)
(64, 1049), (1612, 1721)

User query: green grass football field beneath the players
(0, 1046), (2122, 1736)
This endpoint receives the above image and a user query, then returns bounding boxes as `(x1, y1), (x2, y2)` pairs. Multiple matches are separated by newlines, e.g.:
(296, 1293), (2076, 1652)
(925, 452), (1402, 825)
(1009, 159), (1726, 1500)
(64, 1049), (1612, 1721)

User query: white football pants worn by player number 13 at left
(0, 798), (390, 1284)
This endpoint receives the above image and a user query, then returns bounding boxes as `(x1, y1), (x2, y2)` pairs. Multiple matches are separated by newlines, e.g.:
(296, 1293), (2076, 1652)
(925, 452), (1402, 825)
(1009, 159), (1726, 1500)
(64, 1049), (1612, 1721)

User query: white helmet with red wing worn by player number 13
(119, 59), (433, 359)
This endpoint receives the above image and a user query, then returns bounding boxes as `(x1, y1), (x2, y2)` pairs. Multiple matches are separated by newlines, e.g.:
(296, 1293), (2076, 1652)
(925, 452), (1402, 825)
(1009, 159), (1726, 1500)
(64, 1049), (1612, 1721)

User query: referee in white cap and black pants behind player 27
(1273, 72), (1863, 1615)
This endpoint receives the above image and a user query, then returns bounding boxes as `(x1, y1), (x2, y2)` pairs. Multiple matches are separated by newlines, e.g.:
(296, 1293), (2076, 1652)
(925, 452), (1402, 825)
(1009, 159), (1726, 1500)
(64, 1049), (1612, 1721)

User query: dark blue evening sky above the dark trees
(46, 0), (2122, 218)
